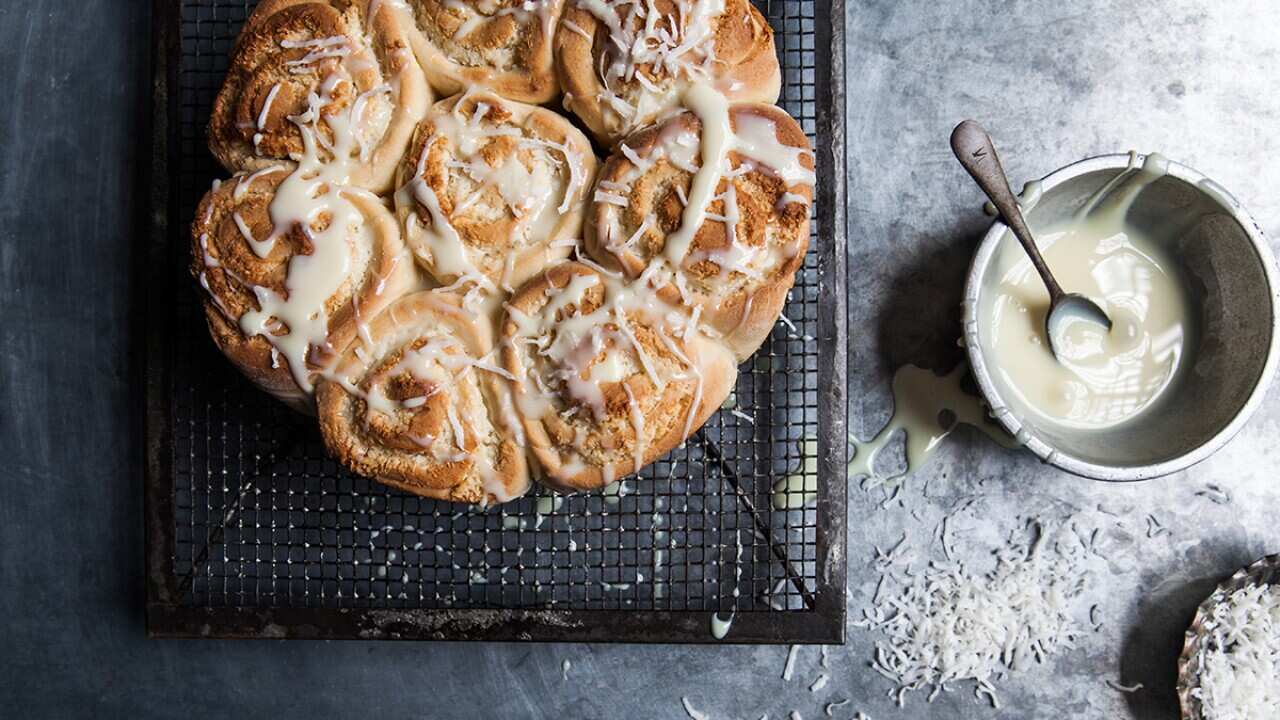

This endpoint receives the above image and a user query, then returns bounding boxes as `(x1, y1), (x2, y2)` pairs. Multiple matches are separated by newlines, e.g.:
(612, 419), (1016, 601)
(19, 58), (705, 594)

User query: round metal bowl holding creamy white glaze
(964, 152), (1280, 480)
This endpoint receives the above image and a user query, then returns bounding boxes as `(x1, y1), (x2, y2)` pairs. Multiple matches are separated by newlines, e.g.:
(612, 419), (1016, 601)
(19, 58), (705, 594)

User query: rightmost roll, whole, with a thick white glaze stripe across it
(584, 86), (814, 361)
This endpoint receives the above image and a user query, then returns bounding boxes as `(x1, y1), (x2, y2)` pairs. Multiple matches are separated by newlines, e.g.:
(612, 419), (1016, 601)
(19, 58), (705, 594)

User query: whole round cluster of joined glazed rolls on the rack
(191, 0), (814, 506)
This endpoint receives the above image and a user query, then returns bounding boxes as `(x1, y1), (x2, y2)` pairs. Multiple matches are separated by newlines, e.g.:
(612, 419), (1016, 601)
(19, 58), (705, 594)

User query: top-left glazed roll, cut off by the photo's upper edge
(209, 0), (430, 192)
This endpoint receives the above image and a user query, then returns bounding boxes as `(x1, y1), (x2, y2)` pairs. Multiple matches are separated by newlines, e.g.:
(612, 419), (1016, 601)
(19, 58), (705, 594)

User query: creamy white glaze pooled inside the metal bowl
(979, 155), (1196, 429)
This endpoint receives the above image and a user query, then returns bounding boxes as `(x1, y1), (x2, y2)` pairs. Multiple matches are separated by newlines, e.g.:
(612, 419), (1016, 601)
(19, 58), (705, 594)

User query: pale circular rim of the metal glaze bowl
(963, 152), (1280, 482)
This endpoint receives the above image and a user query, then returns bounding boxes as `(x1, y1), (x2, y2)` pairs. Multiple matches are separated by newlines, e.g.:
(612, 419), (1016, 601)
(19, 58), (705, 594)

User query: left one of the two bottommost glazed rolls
(316, 292), (529, 505)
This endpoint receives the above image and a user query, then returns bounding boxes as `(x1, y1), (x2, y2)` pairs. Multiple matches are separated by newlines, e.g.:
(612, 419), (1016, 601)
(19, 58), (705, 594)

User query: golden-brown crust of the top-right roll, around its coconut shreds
(556, 0), (782, 146)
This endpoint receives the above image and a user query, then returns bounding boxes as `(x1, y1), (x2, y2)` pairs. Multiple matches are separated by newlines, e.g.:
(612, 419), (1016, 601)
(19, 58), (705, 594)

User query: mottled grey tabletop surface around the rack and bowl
(0, 0), (1280, 720)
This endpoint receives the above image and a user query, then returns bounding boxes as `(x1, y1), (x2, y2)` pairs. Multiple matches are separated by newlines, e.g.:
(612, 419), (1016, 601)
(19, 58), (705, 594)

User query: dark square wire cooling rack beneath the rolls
(140, 0), (846, 643)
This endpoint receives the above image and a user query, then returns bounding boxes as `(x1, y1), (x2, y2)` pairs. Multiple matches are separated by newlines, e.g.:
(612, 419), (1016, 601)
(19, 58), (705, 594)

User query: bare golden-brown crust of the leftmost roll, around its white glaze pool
(191, 164), (417, 413)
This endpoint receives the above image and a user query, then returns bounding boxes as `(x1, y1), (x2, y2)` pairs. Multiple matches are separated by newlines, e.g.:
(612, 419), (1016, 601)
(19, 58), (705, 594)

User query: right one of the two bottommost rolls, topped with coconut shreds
(502, 263), (737, 491)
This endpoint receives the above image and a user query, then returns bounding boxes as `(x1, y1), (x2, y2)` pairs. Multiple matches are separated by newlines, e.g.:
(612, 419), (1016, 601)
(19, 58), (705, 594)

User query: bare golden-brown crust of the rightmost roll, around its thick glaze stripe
(584, 104), (814, 361)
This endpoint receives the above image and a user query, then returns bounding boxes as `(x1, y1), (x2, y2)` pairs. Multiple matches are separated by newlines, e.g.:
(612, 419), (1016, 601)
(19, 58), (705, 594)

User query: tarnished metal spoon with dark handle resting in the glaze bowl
(951, 120), (1111, 359)
